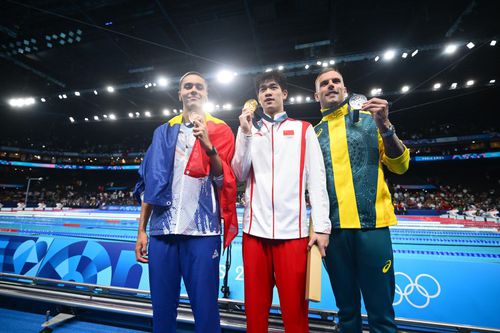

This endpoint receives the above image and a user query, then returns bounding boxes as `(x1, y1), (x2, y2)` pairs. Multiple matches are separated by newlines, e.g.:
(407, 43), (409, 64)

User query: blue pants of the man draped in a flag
(148, 235), (221, 333)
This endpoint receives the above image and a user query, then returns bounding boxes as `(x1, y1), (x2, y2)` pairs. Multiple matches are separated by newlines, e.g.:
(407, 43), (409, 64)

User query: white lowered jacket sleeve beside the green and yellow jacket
(305, 126), (332, 234)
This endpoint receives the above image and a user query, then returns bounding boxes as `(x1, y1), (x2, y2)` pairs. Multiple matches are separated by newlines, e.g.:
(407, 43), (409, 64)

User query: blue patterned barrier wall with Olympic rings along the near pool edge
(0, 235), (500, 328)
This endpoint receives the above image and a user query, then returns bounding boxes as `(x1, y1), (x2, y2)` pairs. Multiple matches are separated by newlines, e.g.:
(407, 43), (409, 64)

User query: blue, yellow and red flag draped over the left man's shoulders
(134, 114), (238, 248)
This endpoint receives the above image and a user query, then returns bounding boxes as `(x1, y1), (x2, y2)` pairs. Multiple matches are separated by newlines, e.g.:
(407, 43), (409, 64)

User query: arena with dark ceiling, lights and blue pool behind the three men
(0, 0), (500, 332)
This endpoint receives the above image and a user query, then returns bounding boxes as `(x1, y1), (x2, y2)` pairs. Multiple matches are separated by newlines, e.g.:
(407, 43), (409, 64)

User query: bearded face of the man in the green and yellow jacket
(314, 71), (347, 109)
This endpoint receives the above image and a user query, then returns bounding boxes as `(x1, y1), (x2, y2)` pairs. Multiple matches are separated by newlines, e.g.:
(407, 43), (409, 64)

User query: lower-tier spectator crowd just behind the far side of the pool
(0, 180), (500, 216)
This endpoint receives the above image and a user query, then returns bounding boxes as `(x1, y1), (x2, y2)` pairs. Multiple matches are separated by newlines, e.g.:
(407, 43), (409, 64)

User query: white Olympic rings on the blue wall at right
(393, 272), (441, 309)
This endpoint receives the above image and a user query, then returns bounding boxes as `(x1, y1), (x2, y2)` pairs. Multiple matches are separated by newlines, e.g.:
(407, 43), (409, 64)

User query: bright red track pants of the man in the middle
(243, 233), (309, 333)
